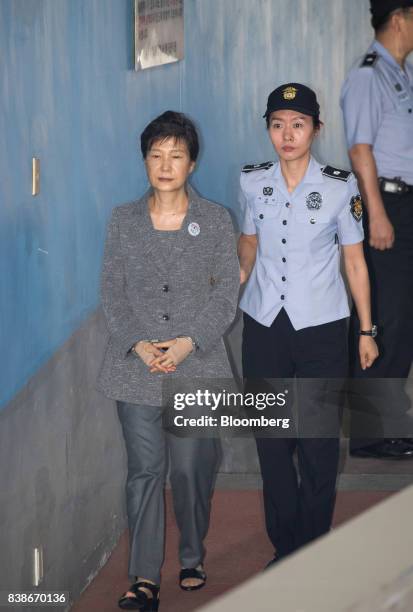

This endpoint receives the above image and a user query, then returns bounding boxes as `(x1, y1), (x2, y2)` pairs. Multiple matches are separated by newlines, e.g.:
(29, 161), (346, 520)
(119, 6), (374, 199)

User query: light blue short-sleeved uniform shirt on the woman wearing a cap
(240, 158), (364, 330)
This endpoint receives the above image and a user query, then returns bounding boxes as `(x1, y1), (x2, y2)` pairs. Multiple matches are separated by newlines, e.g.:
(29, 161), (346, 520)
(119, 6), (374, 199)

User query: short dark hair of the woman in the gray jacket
(141, 111), (199, 161)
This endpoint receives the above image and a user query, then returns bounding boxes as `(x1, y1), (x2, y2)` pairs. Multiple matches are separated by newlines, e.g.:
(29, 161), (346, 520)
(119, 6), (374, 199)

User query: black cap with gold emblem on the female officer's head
(264, 83), (320, 117)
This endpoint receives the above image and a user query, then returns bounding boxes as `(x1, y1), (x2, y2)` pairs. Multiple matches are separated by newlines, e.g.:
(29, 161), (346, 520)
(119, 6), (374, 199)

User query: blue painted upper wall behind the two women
(0, 0), (371, 412)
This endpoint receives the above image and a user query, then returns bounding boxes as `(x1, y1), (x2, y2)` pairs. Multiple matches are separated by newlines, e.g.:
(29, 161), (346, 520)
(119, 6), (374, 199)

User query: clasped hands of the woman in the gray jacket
(135, 338), (193, 373)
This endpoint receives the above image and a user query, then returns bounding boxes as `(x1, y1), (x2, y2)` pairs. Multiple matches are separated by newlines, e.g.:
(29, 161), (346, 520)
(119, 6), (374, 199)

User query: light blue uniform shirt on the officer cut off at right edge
(340, 40), (413, 185)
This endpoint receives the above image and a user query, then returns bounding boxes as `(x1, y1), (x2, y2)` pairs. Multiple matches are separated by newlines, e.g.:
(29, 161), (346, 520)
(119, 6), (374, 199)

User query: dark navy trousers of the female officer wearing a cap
(242, 309), (348, 557)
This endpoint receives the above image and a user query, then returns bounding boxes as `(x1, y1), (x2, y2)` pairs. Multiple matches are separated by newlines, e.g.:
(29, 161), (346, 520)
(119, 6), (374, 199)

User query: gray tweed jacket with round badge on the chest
(98, 186), (239, 406)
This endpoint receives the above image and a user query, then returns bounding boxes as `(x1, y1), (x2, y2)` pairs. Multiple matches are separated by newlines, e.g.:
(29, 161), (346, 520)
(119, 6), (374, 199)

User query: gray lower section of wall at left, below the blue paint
(0, 312), (126, 610)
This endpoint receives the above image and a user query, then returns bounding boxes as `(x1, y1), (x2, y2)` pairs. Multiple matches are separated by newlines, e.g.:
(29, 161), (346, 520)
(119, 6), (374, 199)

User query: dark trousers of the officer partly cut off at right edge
(349, 188), (413, 450)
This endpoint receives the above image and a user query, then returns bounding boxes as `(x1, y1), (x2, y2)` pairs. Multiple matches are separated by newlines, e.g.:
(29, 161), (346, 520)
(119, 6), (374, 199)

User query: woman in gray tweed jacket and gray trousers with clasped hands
(98, 111), (239, 610)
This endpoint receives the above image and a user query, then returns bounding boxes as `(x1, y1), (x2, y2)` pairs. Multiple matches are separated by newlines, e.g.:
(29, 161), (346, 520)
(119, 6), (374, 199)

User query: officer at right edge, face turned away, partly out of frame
(341, 0), (413, 459)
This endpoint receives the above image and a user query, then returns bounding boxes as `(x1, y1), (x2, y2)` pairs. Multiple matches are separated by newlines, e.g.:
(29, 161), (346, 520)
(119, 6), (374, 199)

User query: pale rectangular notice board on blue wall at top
(135, 0), (184, 70)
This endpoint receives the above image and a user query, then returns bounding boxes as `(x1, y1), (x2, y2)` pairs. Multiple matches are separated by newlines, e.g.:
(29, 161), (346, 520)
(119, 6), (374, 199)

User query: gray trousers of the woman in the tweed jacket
(117, 402), (220, 584)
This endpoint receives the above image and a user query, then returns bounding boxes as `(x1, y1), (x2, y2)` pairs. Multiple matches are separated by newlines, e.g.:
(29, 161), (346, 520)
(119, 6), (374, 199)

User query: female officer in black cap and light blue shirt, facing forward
(239, 83), (378, 563)
